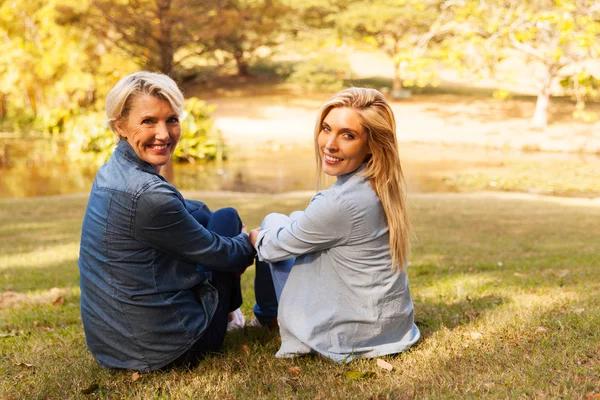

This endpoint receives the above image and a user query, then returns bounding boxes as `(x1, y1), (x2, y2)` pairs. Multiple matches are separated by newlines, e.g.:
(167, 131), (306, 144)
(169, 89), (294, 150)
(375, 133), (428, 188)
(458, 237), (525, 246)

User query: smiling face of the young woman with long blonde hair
(317, 107), (370, 177)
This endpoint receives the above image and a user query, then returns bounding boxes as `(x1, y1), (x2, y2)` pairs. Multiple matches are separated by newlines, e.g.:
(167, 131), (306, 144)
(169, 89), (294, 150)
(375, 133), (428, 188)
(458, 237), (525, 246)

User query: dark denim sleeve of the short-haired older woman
(133, 184), (254, 272)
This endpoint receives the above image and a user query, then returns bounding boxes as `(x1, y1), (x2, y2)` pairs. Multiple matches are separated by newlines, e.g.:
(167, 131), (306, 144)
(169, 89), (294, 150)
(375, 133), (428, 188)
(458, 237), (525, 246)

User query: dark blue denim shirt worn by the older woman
(79, 140), (254, 371)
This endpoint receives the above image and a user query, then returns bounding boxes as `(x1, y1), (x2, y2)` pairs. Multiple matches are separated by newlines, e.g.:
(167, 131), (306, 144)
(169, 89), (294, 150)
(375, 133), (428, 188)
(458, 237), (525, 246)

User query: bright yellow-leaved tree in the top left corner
(0, 0), (126, 123)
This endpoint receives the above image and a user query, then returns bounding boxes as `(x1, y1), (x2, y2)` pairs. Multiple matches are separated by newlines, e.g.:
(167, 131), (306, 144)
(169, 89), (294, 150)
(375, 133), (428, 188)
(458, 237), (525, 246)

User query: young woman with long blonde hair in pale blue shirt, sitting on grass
(250, 88), (420, 361)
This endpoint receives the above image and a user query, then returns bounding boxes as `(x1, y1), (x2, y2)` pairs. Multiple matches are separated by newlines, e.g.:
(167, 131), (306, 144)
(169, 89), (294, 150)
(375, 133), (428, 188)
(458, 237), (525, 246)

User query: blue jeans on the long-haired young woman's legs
(254, 258), (296, 325)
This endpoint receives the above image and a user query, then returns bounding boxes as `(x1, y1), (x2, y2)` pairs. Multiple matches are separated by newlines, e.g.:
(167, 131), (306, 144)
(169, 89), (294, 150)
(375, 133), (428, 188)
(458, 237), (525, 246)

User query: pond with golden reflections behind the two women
(0, 139), (600, 199)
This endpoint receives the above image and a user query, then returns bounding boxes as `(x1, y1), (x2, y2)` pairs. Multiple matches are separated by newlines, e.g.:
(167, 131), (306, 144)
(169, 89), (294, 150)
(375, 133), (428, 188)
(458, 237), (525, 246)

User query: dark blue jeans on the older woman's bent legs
(163, 208), (242, 369)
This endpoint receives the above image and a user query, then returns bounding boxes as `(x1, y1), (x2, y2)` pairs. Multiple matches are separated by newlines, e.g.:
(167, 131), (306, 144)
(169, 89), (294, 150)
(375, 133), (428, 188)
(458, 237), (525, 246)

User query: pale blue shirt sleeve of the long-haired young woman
(256, 192), (353, 262)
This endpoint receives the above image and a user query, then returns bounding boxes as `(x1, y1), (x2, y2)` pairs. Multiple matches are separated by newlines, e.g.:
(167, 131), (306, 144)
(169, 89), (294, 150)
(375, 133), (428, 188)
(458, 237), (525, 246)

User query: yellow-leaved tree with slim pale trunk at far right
(469, 0), (600, 128)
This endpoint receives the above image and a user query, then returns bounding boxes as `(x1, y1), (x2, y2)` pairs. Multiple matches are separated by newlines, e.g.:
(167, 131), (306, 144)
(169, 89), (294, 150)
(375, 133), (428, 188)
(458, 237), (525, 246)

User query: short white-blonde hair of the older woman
(105, 71), (184, 137)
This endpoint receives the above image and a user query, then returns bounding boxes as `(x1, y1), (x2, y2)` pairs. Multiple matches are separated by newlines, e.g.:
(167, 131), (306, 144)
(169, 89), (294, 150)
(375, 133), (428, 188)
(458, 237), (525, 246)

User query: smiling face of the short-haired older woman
(116, 94), (181, 172)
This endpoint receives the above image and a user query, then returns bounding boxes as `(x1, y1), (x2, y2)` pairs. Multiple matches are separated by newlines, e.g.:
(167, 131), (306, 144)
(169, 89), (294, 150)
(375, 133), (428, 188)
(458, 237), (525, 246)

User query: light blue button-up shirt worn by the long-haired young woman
(256, 165), (420, 361)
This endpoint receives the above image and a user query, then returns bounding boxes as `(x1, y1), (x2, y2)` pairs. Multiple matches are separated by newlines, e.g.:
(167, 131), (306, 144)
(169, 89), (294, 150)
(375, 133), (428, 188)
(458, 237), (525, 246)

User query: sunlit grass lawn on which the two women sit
(0, 193), (600, 399)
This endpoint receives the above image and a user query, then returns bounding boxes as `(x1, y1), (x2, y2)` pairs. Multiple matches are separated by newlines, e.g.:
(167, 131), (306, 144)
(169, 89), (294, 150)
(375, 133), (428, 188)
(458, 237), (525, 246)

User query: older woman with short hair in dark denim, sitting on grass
(79, 72), (255, 371)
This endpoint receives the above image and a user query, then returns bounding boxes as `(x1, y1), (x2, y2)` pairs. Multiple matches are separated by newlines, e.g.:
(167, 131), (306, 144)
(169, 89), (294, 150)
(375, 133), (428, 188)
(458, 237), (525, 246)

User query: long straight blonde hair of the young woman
(315, 88), (411, 271)
